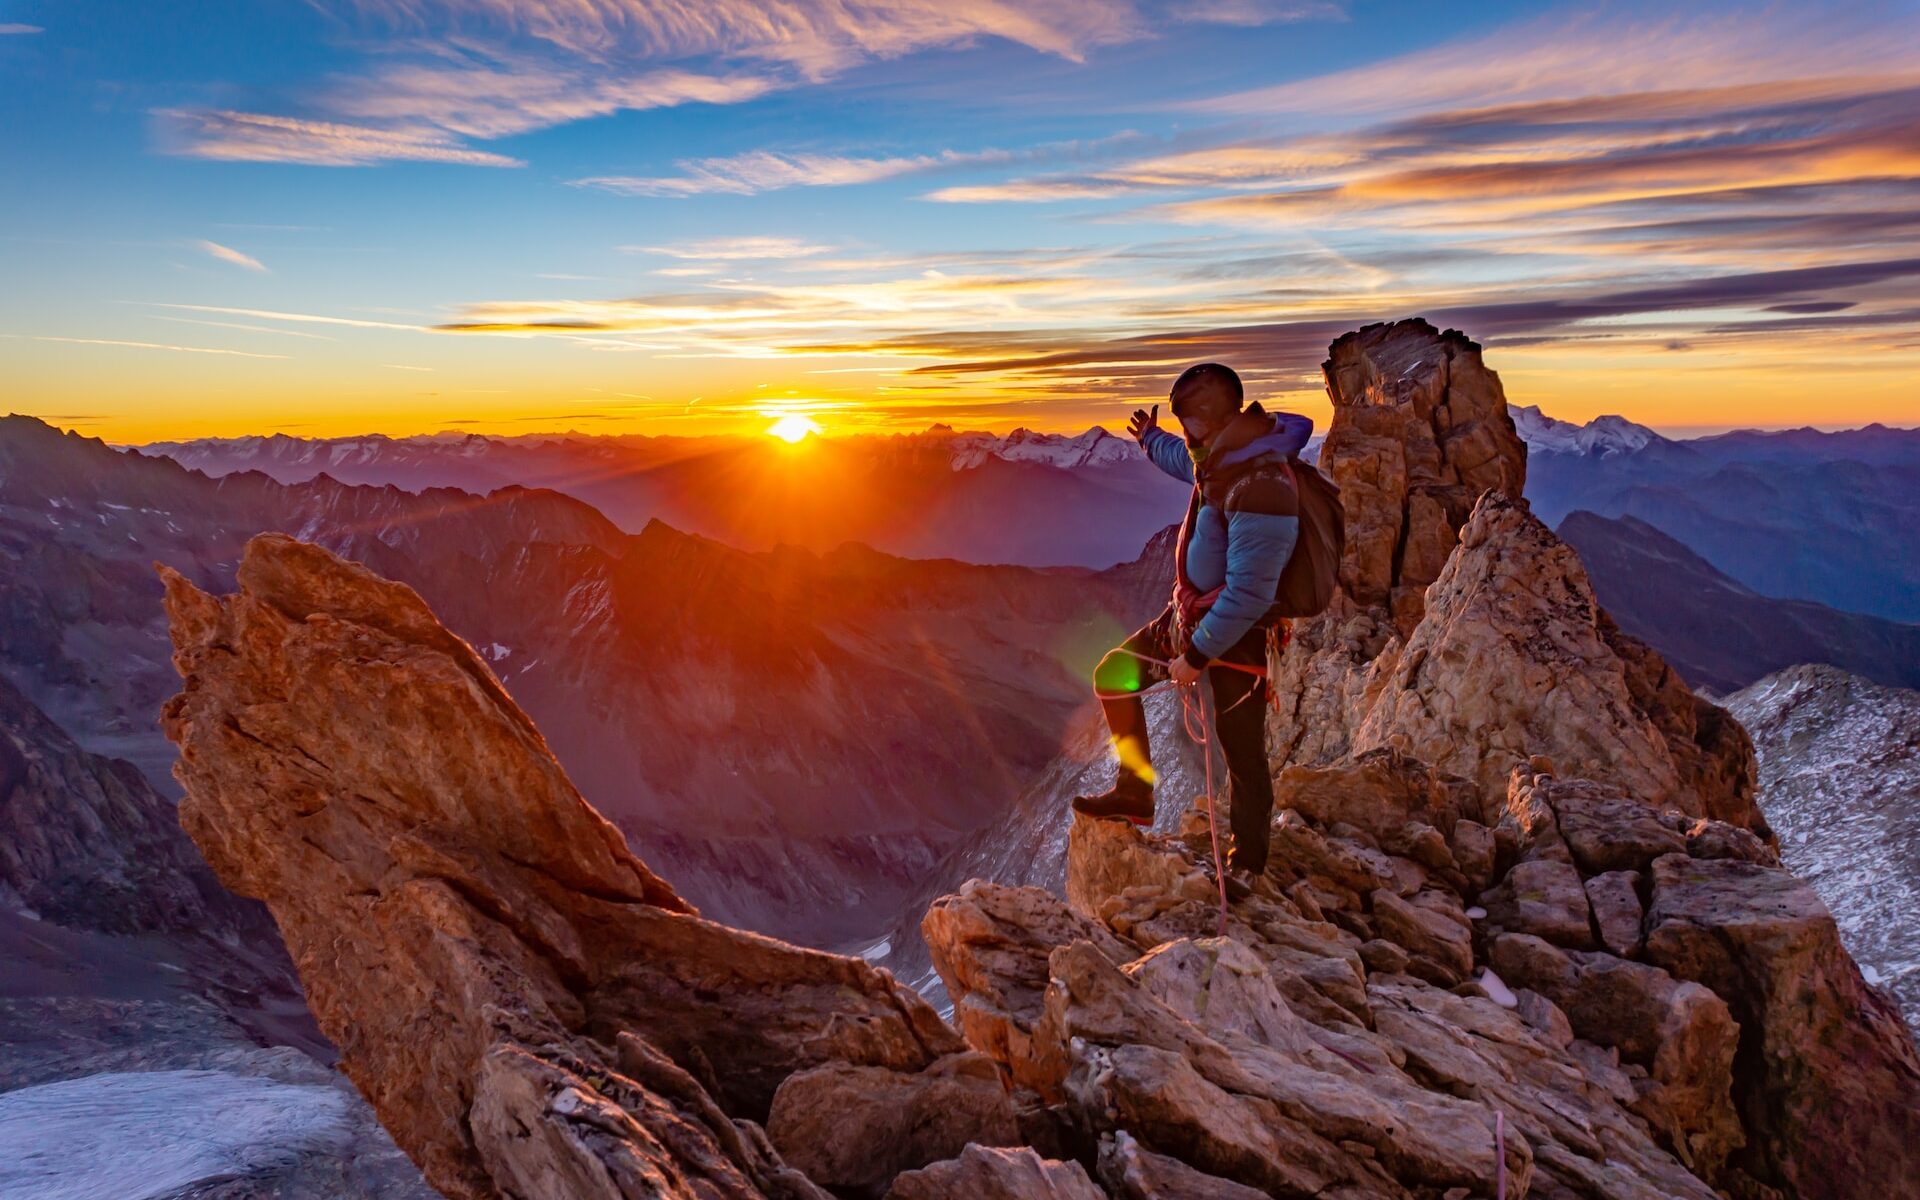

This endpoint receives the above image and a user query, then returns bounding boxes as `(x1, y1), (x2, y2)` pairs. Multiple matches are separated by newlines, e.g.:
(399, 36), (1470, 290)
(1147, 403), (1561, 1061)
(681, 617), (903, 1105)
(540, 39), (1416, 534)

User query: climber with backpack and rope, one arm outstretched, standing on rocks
(1073, 363), (1336, 891)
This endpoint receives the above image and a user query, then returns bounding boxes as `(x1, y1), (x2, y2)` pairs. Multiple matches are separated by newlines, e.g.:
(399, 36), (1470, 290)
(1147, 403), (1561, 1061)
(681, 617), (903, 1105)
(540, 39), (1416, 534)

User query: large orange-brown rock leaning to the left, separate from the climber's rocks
(161, 534), (1012, 1198)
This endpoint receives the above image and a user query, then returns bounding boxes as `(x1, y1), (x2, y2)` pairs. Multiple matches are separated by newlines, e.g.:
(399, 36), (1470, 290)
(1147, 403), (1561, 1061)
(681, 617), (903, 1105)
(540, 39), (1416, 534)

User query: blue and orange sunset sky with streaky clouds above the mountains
(0, 0), (1920, 442)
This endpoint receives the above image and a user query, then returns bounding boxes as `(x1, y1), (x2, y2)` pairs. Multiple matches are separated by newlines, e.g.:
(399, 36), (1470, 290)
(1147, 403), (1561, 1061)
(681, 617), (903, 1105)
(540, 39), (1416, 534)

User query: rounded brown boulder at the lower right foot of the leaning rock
(766, 1050), (1020, 1196)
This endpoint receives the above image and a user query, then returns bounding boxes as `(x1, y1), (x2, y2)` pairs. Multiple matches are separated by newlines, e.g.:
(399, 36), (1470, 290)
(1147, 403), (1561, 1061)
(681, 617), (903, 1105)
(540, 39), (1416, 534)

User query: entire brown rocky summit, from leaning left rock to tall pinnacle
(163, 321), (1920, 1200)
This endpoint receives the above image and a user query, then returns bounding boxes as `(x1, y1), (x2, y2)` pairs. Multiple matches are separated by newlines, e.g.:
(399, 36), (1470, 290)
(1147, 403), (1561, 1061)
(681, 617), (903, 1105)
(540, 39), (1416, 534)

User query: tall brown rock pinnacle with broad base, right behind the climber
(1271, 319), (1764, 831)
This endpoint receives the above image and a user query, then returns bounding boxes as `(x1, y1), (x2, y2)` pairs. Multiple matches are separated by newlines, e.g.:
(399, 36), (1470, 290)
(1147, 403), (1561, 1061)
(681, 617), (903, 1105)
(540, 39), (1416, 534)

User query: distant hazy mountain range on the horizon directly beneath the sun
(142, 426), (1185, 566)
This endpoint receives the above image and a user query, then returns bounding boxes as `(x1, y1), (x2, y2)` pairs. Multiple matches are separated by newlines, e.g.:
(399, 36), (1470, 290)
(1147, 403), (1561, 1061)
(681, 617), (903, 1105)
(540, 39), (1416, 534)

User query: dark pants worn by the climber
(1092, 607), (1273, 874)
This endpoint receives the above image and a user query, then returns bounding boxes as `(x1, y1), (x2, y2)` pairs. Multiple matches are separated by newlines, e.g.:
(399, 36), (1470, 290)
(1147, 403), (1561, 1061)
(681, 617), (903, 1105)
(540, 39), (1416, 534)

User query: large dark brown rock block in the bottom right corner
(1645, 854), (1920, 1200)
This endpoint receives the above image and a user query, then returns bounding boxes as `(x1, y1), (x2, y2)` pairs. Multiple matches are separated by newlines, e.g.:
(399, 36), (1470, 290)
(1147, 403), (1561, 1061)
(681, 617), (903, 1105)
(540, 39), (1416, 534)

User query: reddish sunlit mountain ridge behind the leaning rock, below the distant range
(0, 410), (1156, 943)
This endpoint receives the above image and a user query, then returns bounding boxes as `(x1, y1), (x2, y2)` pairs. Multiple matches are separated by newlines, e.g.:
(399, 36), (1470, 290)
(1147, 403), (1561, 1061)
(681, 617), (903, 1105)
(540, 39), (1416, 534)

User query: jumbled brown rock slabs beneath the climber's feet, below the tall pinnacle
(925, 751), (1920, 1200)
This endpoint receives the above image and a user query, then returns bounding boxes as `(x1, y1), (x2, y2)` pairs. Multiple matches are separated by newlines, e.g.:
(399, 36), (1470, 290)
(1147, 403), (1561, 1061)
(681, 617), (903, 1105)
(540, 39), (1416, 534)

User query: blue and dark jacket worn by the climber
(1140, 401), (1313, 666)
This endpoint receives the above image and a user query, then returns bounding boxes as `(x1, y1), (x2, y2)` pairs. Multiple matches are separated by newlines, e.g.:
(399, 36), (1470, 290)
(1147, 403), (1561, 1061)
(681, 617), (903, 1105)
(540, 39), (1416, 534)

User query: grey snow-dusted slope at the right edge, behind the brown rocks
(1726, 664), (1920, 1029)
